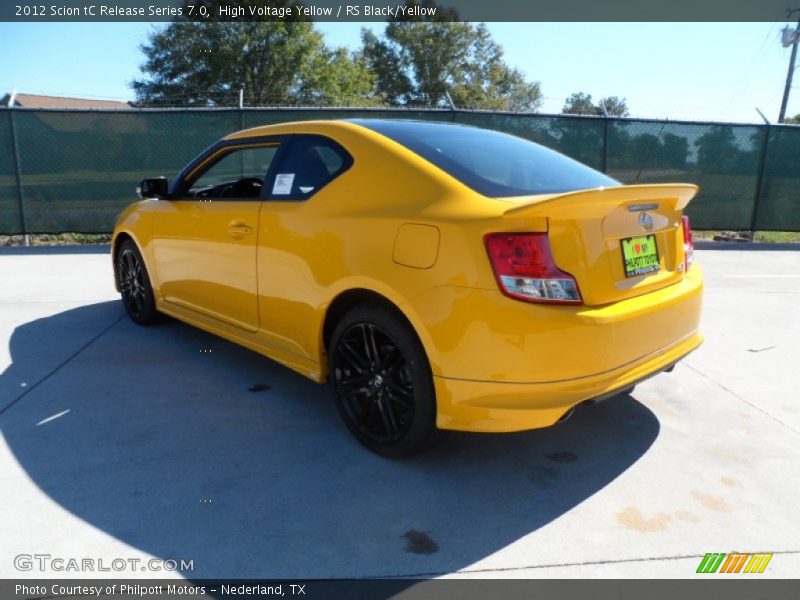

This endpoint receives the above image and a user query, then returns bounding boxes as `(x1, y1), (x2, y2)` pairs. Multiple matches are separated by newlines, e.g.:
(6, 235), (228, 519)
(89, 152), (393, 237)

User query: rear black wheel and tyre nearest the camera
(328, 305), (439, 458)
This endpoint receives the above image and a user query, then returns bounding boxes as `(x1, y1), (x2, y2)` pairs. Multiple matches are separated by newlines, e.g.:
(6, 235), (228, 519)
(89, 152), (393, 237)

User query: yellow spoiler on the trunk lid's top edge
(503, 183), (699, 219)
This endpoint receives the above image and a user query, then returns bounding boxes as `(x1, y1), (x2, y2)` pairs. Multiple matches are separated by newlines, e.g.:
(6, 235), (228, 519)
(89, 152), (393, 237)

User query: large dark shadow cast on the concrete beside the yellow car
(0, 302), (659, 578)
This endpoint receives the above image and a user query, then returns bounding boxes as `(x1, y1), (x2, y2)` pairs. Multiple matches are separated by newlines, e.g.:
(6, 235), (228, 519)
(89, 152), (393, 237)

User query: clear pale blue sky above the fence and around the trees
(0, 23), (800, 123)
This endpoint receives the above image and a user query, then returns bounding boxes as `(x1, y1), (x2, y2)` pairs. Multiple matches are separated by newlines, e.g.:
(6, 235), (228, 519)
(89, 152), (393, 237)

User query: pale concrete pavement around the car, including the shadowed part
(0, 249), (800, 578)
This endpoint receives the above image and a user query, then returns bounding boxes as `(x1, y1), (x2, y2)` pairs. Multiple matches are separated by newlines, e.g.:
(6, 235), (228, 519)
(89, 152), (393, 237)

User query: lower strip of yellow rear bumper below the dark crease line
(434, 333), (703, 433)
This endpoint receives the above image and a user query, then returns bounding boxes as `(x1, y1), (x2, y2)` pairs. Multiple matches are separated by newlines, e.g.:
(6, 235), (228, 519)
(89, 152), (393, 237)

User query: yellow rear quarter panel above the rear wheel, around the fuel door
(250, 124), (498, 371)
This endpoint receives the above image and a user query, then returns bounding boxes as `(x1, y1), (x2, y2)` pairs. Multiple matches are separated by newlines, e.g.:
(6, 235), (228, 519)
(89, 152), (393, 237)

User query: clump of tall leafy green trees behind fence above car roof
(131, 0), (542, 111)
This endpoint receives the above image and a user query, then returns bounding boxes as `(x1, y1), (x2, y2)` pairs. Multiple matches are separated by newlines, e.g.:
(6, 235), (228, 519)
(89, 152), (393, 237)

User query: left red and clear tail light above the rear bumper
(484, 233), (581, 304)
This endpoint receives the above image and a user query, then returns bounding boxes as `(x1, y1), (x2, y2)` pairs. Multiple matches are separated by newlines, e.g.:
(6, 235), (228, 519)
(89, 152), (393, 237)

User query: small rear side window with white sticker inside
(271, 136), (353, 200)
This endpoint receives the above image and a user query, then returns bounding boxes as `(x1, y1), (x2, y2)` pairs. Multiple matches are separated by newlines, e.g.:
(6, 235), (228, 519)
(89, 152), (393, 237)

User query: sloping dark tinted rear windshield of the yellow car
(353, 119), (620, 198)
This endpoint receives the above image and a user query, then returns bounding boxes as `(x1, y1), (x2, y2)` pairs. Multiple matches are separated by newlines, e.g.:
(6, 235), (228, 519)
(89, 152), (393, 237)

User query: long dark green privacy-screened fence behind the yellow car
(0, 108), (800, 235)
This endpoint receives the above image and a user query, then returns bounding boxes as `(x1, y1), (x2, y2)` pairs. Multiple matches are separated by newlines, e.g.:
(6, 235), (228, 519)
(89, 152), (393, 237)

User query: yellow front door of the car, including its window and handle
(153, 140), (279, 332)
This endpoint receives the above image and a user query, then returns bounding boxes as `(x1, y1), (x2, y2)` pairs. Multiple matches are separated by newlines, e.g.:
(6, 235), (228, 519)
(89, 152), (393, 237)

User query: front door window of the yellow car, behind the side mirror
(183, 144), (278, 199)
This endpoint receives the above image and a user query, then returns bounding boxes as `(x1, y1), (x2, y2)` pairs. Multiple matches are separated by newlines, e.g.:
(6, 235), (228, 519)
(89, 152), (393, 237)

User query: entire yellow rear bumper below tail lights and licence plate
(409, 264), (703, 432)
